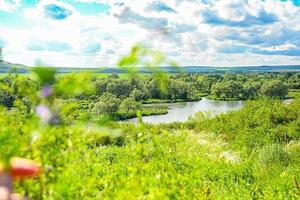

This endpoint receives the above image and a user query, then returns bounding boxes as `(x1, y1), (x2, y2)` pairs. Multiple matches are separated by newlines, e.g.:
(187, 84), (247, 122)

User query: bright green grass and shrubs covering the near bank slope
(0, 99), (300, 199)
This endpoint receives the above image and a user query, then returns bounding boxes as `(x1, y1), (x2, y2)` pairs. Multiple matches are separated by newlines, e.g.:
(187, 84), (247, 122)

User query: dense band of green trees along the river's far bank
(0, 72), (300, 115)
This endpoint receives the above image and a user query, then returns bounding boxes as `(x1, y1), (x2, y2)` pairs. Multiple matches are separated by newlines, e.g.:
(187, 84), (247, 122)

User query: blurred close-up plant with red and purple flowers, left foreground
(0, 45), (179, 199)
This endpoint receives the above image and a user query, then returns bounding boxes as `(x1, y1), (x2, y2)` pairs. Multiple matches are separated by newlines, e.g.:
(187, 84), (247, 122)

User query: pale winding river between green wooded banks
(126, 98), (243, 124)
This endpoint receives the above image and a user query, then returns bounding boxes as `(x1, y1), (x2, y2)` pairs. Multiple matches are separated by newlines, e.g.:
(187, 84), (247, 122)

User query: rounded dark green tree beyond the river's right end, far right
(260, 80), (288, 98)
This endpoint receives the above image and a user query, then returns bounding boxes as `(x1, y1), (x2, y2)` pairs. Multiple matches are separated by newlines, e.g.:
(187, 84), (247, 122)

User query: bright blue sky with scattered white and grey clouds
(0, 0), (300, 67)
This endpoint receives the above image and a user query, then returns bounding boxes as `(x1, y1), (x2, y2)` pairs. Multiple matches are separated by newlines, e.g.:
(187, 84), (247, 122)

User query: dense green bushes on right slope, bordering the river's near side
(191, 99), (300, 150)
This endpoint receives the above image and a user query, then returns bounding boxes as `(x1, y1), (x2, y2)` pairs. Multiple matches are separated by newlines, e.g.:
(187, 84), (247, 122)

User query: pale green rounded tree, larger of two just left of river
(95, 93), (121, 115)
